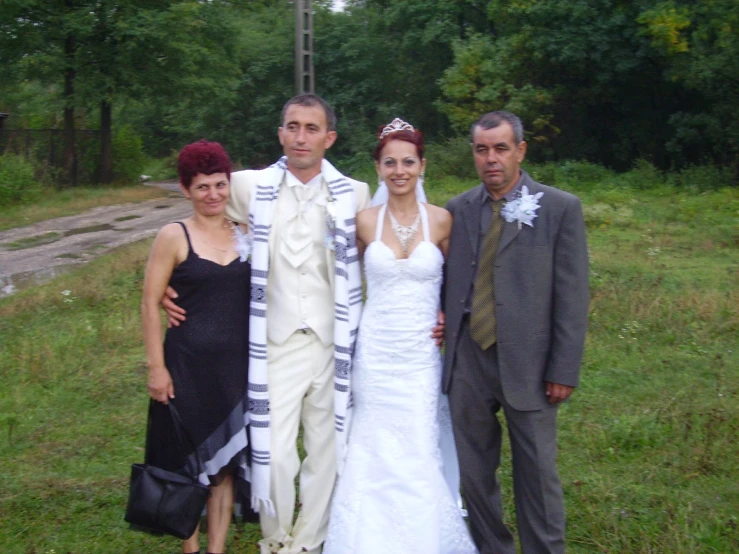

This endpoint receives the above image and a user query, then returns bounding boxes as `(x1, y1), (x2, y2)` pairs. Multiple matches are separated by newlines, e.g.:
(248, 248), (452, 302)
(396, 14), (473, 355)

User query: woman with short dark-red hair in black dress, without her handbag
(141, 140), (250, 553)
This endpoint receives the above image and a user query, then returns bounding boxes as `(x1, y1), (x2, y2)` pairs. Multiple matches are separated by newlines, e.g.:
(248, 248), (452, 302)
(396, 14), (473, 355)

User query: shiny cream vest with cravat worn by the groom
(267, 174), (334, 346)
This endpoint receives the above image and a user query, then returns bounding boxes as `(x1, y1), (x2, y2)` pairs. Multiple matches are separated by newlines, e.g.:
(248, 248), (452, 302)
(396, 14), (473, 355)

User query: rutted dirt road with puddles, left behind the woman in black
(0, 181), (192, 298)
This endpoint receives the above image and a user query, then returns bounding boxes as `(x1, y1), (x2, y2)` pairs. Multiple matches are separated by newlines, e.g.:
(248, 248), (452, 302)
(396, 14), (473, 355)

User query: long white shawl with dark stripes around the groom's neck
(248, 157), (362, 514)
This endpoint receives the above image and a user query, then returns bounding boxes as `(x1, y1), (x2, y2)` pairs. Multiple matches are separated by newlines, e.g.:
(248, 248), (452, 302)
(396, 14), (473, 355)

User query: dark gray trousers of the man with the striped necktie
(449, 322), (565, 554)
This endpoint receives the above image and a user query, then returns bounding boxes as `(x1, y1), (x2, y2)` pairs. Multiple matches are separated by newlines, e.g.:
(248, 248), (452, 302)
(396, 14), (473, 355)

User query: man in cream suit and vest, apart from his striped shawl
(164, 94), (370, 554)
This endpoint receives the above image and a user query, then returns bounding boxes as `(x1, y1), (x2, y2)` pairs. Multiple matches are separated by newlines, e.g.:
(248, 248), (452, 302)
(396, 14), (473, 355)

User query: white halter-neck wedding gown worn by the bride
(323, 204), (477, 554)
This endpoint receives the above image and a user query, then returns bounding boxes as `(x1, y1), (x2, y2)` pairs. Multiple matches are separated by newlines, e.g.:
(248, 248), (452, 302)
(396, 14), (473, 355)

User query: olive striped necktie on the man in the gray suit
(470, 198), (505, 350)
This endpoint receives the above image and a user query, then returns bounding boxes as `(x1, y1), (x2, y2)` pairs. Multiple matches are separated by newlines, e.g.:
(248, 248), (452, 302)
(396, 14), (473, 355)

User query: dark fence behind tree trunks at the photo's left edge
(0, 129), (100, 183)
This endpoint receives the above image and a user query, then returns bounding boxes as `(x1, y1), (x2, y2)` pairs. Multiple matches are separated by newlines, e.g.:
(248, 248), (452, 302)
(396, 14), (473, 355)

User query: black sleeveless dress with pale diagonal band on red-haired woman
(146, 222), (251, 493)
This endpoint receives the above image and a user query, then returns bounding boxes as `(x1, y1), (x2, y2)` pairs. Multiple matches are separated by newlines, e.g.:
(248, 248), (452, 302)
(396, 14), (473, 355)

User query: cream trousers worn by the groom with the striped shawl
(259, 332), (336, 554)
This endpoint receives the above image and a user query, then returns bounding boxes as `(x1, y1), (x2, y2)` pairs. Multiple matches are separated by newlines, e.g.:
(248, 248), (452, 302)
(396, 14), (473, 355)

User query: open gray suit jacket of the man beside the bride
(443, 171), (589, 411)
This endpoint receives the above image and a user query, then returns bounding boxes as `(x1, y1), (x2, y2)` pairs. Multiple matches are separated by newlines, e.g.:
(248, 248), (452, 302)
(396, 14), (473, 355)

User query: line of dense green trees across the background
(0, 0), (739, 182)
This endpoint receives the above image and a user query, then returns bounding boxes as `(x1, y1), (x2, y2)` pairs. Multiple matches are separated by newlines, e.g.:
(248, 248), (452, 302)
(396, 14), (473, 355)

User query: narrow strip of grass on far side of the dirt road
(0, 185), (170, 231)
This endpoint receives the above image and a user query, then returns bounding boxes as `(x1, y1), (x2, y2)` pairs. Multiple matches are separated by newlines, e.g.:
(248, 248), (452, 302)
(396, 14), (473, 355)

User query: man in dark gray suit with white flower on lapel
(443, 112), (589, 554)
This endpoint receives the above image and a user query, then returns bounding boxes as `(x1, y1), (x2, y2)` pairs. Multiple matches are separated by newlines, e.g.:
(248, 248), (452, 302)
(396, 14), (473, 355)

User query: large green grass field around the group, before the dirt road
(0, 172), (739, 554)
